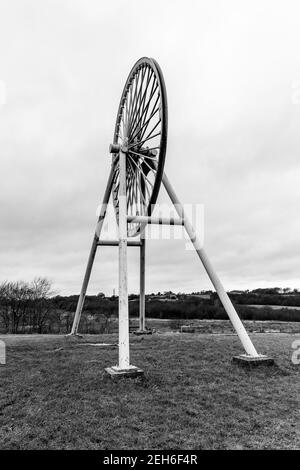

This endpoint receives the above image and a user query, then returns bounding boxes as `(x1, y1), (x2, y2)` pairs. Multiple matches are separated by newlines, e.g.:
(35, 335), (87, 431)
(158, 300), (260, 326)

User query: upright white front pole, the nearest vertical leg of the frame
(119, 149), (130, 370)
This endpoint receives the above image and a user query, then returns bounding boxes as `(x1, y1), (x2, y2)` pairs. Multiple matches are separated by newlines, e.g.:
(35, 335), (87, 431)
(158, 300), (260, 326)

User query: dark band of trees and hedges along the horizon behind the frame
(0, 277), (300, 334)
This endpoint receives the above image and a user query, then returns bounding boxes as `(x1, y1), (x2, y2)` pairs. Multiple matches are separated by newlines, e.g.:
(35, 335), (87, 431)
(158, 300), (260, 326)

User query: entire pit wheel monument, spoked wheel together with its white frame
(71, 58), (261, 373)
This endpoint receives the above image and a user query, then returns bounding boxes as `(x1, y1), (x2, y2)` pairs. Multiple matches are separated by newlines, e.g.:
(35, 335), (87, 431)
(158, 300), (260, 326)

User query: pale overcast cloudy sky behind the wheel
(0, 0), (300, 294)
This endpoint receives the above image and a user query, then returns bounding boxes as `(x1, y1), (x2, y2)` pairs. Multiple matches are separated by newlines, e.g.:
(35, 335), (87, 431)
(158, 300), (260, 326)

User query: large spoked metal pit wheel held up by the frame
(111, 57), (168, 237)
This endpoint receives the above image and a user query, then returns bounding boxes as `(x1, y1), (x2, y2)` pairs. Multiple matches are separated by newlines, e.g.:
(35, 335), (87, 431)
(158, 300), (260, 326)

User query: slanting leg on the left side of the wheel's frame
(70, 165), (114, 335)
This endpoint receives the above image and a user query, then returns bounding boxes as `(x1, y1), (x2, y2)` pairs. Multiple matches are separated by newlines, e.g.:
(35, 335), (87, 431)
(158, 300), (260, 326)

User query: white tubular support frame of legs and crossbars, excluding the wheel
(72, 169), (259, 360)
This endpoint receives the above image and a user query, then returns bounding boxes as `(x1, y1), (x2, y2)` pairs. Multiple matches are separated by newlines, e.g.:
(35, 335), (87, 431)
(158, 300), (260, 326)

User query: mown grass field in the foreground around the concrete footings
(0, 333), (300, 450)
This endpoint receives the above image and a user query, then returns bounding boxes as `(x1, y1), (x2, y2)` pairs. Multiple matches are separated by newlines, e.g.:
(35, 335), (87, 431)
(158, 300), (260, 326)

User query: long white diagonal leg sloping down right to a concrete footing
(162, 173), (259, 357)
